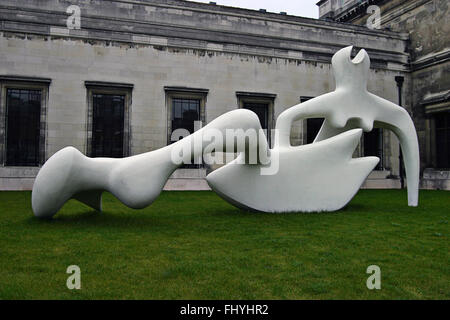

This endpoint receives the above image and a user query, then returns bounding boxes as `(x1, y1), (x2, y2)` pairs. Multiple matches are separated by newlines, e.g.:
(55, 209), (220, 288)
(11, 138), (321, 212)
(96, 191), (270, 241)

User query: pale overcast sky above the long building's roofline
(186, 0), (319, 18)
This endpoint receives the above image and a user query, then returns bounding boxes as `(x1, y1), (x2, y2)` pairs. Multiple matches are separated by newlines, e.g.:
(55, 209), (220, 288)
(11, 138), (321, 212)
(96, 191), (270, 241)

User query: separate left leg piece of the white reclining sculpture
(32, 109), (268, 218)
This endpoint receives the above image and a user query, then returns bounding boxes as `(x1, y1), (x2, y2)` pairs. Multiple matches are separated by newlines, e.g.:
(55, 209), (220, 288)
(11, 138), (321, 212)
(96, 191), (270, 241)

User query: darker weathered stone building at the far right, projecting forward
(317, 0), (450, 190)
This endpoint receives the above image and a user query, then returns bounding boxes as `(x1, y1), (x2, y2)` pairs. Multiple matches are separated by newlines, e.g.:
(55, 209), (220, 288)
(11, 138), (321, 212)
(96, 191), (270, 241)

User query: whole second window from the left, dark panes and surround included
(86, 82), (133, 158)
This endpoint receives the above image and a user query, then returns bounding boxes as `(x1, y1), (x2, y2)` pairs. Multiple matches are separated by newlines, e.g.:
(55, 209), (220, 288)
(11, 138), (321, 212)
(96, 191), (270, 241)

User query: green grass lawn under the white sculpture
(0, 190), (450, 299)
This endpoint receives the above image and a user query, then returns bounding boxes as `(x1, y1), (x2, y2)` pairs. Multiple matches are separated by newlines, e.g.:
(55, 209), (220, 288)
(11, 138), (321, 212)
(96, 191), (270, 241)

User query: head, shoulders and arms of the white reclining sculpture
(275, 47), (420, 206)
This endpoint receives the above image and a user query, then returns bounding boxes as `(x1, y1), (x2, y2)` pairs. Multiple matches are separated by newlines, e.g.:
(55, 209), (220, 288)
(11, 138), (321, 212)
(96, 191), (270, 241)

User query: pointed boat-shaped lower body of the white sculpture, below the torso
(206, 129), (380, 212)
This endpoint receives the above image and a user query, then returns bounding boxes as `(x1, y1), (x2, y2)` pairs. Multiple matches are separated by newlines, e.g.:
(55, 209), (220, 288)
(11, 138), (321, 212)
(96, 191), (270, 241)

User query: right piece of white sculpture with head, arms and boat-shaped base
(207, 46), (420, 212)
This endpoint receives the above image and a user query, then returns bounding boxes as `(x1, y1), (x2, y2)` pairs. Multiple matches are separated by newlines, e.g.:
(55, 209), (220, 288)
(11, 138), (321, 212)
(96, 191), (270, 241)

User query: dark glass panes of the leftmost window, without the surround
(6, 89), (42, 166)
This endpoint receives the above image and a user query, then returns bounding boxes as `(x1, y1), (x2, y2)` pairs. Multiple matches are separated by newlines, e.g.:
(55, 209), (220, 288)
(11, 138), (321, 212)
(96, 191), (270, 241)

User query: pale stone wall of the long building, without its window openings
(0, 0), (422, 190)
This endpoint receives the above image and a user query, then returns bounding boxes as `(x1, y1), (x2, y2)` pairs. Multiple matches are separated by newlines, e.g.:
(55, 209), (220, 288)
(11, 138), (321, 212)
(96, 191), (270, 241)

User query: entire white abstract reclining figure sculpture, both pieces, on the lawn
(32, 47), (419, 218)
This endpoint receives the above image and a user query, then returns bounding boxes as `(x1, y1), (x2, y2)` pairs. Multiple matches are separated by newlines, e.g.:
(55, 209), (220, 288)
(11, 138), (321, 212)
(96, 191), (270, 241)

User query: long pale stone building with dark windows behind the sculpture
(0, 0), (442, 190)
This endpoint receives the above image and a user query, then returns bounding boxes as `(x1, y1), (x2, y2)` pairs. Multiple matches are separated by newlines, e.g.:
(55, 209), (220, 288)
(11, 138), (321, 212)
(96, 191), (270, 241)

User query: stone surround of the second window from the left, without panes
(85, 81), (134, 158)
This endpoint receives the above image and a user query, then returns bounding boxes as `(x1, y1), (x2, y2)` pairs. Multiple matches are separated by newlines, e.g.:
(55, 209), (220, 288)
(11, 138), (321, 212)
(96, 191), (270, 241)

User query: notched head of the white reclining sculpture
(331, 46), (370, 89)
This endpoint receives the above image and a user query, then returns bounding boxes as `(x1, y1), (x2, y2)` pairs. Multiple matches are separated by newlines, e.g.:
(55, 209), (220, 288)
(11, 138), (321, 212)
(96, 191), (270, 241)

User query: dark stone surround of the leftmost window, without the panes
(0, 76), (51, 168)
